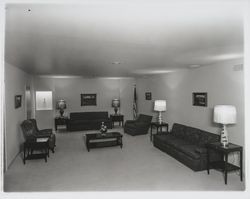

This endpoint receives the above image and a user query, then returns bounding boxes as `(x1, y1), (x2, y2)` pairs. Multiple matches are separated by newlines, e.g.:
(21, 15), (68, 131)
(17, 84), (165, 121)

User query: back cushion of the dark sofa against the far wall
(70, 111), (108, 120)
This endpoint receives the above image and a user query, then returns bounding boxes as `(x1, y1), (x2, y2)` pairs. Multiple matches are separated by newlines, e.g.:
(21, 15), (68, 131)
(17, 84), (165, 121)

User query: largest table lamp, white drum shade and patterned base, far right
(214, 105), (236, 147)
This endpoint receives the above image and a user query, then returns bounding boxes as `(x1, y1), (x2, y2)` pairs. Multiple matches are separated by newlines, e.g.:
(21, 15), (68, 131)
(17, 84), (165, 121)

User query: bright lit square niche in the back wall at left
(36, 91), (53, 111)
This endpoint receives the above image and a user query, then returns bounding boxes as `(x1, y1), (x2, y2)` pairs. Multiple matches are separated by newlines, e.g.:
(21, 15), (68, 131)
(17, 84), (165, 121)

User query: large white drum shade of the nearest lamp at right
(214, 105), (236, 124)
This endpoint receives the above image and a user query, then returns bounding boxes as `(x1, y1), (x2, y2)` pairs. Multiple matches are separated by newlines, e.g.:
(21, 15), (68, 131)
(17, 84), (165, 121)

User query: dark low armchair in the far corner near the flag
(124, 114), (152, 136)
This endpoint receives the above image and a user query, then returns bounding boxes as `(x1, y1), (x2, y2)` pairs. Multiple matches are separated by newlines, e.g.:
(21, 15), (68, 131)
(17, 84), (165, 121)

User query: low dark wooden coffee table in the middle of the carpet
(86, 132), (123, 151)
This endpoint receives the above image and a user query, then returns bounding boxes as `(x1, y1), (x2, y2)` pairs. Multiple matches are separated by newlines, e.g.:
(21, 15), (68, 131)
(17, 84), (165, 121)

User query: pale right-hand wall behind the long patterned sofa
(137, 60), (244, 146)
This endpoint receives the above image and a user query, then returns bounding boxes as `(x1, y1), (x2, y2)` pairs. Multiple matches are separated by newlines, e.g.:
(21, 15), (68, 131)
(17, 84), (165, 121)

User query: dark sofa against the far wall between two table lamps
(67, 111), (112, 131)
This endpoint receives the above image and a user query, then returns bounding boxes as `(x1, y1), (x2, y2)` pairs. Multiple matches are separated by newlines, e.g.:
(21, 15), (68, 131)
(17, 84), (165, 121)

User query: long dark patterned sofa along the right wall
(153, 123), (221, 171)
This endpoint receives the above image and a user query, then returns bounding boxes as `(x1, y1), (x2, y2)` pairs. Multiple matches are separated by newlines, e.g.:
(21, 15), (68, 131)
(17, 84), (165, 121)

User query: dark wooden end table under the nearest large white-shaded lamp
(207, 142), (243, 184)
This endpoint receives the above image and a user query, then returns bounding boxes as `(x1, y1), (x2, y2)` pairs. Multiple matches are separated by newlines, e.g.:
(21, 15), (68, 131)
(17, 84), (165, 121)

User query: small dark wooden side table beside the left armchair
(23, 138), (49, 164)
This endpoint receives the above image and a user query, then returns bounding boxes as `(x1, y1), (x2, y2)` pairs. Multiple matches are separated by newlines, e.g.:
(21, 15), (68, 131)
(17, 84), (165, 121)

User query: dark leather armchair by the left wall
(21, 119), (56, 153)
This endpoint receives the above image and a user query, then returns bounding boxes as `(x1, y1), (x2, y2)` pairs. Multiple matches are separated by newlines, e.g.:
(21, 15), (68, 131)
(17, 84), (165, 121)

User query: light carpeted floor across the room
(4, 128), (245, 192)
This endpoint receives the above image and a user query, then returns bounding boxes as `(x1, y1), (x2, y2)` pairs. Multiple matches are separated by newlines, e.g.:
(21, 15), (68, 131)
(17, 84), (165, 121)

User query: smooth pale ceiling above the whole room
(5, 0), (244, 77)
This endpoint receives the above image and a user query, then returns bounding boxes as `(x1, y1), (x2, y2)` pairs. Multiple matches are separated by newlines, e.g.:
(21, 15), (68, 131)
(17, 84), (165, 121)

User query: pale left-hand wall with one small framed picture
(5, 63), (32, 166)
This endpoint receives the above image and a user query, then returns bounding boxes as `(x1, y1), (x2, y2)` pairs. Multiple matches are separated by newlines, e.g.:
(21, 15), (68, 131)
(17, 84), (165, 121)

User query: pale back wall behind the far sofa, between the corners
(34, 77), (135, 128)
